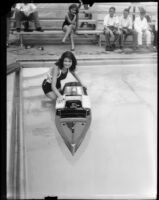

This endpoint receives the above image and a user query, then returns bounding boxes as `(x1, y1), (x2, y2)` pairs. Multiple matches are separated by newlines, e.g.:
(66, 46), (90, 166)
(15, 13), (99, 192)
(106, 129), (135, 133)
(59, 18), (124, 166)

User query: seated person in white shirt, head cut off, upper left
(15, 3), (43, 32)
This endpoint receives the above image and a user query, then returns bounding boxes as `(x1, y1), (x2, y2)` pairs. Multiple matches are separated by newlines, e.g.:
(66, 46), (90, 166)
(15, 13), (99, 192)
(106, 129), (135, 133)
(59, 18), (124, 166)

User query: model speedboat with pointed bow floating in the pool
(55, 82), (91, 155)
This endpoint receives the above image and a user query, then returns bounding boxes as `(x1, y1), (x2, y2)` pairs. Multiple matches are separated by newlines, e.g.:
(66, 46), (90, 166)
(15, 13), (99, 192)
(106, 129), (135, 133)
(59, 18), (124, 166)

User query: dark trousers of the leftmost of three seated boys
(104, 26), (120, 46)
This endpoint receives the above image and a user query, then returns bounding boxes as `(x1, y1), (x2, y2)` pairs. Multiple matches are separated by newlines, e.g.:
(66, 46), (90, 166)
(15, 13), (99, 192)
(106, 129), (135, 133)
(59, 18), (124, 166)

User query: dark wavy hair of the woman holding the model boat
(55, 51), (77, 72)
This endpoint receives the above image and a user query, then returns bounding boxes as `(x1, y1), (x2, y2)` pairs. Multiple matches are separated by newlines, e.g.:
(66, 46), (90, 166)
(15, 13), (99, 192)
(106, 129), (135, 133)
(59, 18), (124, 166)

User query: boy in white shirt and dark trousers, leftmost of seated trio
(104, 7), (121, 51)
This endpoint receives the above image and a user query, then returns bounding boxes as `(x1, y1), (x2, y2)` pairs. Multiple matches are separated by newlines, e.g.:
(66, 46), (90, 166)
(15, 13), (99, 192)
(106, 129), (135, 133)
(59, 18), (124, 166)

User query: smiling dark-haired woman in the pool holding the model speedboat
(42, 51), (83, 101)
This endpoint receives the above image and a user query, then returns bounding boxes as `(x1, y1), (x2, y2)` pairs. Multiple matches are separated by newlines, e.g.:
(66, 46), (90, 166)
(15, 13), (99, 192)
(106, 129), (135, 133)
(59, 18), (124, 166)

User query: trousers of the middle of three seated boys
(119, 28), (137, 47)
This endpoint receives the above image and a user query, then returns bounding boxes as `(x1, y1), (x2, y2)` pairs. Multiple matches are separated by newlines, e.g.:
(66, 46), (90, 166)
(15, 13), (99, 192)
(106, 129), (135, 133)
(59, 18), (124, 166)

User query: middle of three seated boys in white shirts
(119, 7), (137, 49)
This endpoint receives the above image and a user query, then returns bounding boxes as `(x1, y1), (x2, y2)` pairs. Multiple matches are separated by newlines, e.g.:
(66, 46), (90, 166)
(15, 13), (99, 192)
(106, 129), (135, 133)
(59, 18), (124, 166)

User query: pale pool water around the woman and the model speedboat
(8, 59), (157, 199)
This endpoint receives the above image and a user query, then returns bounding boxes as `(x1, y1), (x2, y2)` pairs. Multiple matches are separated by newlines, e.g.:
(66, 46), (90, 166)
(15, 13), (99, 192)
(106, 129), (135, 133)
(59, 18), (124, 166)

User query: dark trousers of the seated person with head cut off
(15, 11), (40, 28)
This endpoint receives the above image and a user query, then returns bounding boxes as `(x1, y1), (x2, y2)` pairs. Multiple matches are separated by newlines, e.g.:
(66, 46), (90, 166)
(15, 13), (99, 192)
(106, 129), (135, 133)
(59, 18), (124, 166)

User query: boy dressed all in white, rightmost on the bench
(134, 8), (151, 47)
